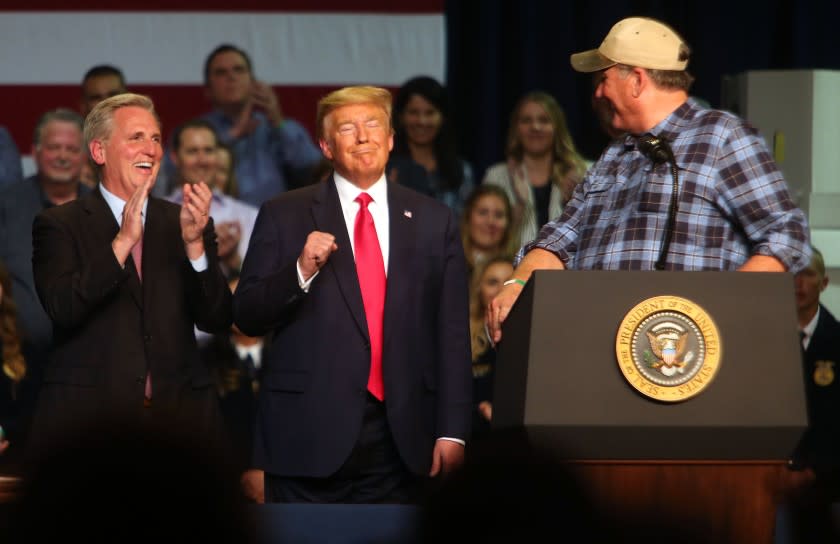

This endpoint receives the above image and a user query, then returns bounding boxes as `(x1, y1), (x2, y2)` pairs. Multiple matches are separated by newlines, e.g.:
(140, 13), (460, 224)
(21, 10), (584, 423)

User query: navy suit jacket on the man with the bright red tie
(234, 178), (472, 477)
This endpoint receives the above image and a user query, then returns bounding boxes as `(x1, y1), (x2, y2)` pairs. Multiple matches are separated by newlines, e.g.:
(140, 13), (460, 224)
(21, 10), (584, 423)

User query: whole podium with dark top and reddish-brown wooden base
(493, 271), (807, 543)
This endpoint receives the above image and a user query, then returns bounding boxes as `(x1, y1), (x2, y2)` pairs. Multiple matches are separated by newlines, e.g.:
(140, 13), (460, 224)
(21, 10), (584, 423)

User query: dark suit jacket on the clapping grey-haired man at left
(33, 189), (232, 439)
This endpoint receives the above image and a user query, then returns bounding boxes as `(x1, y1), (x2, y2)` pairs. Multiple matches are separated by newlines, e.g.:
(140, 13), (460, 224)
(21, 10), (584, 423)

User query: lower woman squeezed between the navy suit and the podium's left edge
(470, 255), (513, 435)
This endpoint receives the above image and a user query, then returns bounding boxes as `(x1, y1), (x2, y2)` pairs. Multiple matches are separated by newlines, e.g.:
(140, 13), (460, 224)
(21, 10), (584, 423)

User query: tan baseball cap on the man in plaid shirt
(570, 17), (690, 72)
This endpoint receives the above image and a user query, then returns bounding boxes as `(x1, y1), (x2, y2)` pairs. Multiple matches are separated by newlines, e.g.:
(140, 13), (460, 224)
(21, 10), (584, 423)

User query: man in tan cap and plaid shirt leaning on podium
(487, 17), (811, 341)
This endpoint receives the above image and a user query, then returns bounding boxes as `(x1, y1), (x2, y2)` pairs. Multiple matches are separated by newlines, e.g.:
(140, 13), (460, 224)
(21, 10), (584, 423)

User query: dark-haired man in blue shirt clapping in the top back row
(158, 44), (321, 207)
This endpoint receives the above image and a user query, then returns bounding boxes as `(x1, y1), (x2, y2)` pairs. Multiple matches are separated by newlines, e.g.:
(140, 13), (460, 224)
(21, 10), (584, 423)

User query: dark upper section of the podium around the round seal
(493, 271), (807, 459)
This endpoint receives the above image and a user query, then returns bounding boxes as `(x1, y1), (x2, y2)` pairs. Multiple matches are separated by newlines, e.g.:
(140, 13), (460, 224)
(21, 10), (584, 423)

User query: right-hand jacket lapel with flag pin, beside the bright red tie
(383, 182), (417, 353)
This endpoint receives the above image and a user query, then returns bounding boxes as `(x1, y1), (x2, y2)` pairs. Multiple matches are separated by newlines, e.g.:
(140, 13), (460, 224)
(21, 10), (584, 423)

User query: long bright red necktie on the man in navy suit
(353, 193), (385, 400)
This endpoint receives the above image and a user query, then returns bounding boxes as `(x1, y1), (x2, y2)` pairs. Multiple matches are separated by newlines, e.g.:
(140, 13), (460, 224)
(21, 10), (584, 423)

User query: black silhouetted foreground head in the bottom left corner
(0, 419), (256, 544)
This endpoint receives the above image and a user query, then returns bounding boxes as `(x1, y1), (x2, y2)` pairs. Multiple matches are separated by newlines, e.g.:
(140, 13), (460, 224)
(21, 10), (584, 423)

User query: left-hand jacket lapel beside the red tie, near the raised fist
(312, 177), (368, 338)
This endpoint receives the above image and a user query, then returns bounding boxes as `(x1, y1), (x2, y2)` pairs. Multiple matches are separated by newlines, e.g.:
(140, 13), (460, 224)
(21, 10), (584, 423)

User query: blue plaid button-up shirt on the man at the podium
(519, 99), (811, 273)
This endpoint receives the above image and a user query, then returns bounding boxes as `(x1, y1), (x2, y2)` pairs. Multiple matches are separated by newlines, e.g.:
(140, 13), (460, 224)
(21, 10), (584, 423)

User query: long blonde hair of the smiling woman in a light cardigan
(506, 91), (586, 203)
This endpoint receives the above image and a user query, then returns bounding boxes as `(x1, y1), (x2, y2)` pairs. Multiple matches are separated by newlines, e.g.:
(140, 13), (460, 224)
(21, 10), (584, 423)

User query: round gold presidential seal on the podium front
(615, 295), (720, 402)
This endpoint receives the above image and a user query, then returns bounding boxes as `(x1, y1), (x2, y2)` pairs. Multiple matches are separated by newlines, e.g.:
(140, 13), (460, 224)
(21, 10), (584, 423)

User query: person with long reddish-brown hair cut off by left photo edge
(0, 262), (40, 475)
